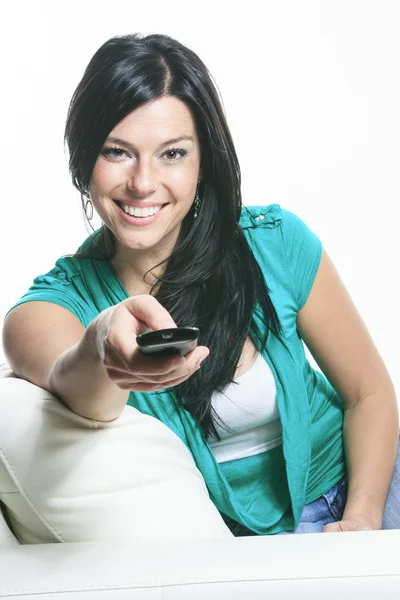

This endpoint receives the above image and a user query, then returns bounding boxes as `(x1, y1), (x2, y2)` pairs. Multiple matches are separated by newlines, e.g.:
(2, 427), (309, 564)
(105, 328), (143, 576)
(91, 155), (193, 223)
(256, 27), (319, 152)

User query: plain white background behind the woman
(0, 0), (400, 393)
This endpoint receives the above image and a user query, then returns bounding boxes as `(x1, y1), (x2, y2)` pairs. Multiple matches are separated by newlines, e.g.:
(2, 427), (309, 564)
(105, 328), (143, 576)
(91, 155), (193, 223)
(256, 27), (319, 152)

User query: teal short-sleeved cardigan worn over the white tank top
(4, 204), (346, 534)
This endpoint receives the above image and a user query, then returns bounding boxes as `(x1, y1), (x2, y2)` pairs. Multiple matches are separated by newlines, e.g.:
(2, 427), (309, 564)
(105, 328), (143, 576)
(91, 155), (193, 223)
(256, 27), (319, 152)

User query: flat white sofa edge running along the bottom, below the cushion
(0, 531), (400, 600)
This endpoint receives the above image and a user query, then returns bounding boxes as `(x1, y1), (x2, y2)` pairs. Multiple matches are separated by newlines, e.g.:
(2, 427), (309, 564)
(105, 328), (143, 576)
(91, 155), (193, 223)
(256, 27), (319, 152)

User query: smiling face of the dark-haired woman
(89, 96), (200, 254)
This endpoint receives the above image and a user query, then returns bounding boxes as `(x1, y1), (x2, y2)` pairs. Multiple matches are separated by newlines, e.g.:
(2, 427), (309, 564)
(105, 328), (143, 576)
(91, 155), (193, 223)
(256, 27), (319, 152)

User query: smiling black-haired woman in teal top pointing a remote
(3, 35), (400, 535)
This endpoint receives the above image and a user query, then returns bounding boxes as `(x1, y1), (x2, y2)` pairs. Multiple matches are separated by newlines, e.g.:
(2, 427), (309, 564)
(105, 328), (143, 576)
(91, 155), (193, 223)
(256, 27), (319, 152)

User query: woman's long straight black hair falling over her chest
(65, 34), (281, 439)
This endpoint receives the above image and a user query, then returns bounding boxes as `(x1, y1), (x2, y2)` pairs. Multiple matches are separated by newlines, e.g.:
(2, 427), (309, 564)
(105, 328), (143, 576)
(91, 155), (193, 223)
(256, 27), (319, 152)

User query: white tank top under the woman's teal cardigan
(208, 354), (282, 463)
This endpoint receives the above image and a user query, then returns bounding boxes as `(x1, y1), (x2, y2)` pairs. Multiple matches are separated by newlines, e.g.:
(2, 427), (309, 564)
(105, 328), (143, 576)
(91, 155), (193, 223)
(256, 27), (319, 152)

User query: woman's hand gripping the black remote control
(89, 294), (209, 392)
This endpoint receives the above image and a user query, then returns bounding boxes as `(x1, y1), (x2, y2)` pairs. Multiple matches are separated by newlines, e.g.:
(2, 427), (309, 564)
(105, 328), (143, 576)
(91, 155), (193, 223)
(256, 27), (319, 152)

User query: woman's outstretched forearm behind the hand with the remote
(48, 326), (129, 421)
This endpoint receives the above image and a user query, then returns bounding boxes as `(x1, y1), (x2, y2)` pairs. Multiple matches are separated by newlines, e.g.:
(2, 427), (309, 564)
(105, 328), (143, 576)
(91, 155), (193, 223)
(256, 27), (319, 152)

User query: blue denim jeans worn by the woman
(230, 434), (400, 536)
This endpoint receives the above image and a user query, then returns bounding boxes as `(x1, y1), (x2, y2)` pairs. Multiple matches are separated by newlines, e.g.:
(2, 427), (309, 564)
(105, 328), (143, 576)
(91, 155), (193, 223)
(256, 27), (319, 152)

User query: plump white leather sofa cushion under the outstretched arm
(0, 377), (232, 544)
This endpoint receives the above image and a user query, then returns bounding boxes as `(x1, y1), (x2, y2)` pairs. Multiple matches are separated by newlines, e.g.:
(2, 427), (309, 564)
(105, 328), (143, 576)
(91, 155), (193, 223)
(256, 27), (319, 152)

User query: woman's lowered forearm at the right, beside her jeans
(343, 386), (399, 529)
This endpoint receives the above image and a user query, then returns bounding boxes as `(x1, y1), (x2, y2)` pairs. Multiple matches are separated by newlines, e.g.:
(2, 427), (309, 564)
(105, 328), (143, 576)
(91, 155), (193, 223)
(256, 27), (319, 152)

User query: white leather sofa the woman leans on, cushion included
(0, 358), (400, 600)
